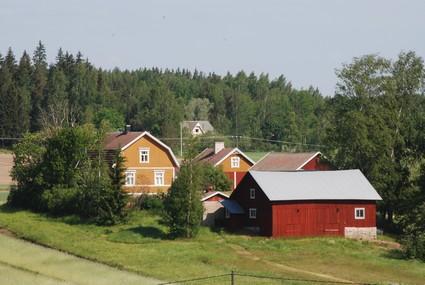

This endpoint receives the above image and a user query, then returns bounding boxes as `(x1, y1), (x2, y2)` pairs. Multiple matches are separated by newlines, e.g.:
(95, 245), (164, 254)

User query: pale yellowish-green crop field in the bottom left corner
(0, 231), (161, 285)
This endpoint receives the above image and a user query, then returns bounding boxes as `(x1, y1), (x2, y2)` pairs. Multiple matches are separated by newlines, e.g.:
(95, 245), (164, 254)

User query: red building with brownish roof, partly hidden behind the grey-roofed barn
(251, 152), (331, 171)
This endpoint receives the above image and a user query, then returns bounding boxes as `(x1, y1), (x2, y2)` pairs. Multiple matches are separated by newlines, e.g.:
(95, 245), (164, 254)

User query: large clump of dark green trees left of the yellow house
(8, 126), (127, 225)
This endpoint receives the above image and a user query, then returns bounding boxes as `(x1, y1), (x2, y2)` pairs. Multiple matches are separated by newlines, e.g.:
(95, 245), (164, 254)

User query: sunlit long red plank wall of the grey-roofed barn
(272, 201), (376, 237)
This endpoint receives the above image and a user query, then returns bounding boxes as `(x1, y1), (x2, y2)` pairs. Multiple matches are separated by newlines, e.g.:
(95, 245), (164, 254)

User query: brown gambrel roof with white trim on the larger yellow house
(104, 132), (180, 167)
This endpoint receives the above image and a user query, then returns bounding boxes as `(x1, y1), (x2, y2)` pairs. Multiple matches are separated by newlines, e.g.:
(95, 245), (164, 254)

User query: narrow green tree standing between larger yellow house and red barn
(163, 161), (203, 238)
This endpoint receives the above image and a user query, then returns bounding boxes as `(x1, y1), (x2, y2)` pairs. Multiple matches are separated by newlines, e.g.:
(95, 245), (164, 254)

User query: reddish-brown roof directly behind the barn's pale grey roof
(251, 152), (321, 171)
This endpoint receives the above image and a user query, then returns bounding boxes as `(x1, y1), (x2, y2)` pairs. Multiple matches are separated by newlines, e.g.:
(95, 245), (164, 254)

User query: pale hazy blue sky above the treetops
(0, 0), (425, 95)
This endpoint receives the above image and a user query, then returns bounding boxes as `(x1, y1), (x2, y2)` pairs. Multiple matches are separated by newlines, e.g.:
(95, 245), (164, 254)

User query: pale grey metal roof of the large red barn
(249, 169), (382, 201)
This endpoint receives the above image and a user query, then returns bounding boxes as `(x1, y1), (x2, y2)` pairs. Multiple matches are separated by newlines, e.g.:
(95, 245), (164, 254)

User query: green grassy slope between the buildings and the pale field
(0, 206), (425, 284)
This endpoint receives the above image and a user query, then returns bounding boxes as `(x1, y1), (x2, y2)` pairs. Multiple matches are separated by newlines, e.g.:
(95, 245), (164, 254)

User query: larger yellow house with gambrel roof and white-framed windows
(104, 131), (179, 194)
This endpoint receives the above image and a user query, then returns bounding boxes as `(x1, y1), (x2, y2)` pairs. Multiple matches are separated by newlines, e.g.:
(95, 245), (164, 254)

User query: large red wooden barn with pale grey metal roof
(222, 170), (382, 238)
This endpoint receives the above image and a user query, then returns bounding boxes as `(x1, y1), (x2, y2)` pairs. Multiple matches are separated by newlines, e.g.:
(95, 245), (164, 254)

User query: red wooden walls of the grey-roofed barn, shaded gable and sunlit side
(227, 173), (376, 237)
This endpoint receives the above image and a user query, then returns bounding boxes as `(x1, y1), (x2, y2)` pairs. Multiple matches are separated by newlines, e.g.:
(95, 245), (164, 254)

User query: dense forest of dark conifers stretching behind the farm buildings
(0, 42), (325, 150)
